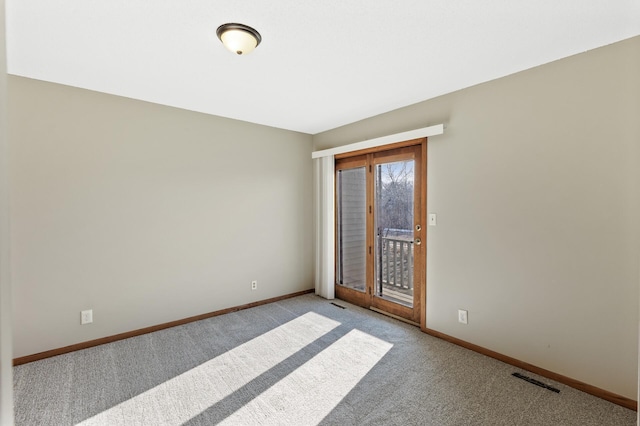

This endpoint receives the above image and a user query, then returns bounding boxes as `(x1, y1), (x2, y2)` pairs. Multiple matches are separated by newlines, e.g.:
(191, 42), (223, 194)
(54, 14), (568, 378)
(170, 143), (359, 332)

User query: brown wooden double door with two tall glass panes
(335, 139), (426, 324)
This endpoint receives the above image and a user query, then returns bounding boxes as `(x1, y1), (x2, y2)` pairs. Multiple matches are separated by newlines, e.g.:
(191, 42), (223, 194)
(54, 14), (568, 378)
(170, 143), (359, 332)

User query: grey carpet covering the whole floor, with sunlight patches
(14, 295), (636, 426)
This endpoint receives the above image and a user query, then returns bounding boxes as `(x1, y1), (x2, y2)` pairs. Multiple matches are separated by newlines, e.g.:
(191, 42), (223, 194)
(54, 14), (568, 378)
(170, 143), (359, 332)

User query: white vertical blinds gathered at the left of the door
(313, 155), (335, 299)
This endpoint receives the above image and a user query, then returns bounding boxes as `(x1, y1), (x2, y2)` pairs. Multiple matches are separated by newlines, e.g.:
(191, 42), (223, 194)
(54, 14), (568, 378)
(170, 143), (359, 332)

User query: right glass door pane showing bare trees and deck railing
(374, 160), (415, 307)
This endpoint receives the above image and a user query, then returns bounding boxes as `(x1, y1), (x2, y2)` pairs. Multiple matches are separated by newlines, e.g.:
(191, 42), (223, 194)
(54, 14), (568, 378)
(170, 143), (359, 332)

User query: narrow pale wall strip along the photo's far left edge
(0, 0), (13, 425)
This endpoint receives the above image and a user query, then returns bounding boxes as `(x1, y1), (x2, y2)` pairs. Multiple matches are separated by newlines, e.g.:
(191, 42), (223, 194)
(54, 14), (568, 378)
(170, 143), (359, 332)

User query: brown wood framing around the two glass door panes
(334, 138), (427, 329)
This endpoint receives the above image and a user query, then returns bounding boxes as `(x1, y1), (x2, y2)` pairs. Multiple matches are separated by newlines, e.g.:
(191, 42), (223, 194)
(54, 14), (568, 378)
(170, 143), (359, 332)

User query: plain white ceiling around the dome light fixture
(6, 0), (640, 134)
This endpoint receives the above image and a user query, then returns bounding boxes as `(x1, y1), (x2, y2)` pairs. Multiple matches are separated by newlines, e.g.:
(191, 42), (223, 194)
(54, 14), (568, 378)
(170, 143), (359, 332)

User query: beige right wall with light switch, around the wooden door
(314, 37), (640, 399)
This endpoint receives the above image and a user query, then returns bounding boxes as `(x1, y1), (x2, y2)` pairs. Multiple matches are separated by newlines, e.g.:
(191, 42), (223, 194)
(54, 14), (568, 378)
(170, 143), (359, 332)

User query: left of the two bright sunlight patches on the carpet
(80, 312), (340, 426)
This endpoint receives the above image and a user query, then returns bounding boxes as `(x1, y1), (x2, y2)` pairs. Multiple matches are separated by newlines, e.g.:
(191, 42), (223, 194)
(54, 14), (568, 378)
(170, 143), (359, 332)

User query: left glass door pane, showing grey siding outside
(336, 167), (367, 292)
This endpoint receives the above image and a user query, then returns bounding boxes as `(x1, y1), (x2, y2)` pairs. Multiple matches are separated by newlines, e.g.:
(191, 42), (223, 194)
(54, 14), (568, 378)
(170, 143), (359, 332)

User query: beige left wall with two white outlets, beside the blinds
(8, 76), (313, 357)
